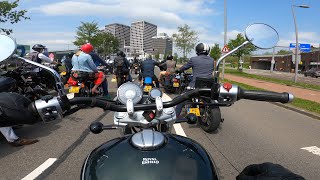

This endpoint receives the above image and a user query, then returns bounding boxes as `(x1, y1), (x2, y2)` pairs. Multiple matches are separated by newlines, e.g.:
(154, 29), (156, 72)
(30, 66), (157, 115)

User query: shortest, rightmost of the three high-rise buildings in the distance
(152, 33), (172, 55)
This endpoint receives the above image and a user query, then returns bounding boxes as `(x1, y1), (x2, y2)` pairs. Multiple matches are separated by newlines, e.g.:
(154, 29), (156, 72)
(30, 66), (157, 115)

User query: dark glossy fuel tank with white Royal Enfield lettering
(81, 134), (218, 180)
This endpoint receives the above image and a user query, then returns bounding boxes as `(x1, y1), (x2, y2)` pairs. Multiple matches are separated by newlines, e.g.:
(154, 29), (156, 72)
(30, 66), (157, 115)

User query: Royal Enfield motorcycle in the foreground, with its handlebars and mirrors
(0, 24), (294, 180)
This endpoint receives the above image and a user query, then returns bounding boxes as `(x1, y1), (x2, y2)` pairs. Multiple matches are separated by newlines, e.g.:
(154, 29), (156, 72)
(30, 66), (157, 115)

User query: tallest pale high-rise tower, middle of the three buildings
(130, 21), (157, 55)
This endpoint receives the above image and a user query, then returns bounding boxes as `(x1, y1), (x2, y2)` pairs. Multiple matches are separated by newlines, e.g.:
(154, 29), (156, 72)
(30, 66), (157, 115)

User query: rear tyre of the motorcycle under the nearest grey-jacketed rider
(198, 107), (221, 133)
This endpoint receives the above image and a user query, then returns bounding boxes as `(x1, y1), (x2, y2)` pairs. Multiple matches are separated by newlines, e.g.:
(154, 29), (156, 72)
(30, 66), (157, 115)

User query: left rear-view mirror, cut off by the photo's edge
(0, 35), (17, 62)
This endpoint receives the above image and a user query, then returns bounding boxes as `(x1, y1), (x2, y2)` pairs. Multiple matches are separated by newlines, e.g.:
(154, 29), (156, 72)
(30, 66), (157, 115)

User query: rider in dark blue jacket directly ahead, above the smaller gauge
(139, 56), (161, 88)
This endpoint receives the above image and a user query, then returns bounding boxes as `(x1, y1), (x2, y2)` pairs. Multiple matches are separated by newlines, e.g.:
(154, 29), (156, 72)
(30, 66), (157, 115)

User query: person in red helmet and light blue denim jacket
(72, 43), (105, 93)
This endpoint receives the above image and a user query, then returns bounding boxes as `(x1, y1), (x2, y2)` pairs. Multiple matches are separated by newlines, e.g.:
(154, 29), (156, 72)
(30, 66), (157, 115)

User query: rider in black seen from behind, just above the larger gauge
(113, 51), (132, 87)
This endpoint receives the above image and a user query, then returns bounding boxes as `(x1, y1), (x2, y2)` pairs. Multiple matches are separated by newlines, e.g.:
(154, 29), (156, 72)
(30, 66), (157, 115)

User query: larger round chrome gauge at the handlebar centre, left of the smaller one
(117, 82), (143, 104)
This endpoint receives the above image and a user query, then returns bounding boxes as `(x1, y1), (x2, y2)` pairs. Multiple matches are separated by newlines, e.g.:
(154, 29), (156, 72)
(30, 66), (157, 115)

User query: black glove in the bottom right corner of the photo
(236, 162), (304, 180)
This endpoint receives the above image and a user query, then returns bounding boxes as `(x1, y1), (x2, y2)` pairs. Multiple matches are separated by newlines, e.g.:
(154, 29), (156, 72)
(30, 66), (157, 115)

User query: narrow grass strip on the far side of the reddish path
(225, 69), (320, 90)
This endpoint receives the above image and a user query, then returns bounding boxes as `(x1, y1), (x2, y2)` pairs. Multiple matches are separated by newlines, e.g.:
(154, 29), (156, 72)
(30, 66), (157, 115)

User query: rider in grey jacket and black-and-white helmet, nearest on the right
(176, 43), (214, 118)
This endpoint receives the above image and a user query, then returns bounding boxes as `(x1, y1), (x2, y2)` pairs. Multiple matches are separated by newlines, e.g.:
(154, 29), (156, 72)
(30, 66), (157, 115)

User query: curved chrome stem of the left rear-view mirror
(13, 55), (66, 97)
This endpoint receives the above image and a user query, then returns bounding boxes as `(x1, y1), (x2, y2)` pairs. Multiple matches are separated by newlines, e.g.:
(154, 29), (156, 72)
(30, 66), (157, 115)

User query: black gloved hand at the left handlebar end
(0, 92), (39, 127)
